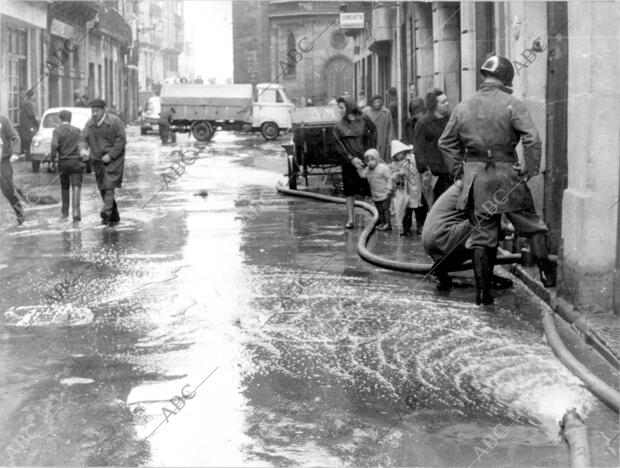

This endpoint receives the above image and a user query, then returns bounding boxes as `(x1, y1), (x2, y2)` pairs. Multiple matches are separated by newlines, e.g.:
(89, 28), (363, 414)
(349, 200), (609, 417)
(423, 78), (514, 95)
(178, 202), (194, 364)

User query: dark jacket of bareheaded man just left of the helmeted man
(413, 112), (450, 175)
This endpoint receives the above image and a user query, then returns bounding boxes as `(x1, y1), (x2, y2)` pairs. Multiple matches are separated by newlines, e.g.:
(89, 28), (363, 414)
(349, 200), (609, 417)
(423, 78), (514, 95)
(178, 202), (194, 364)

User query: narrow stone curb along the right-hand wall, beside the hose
(500, 249), (620, 370)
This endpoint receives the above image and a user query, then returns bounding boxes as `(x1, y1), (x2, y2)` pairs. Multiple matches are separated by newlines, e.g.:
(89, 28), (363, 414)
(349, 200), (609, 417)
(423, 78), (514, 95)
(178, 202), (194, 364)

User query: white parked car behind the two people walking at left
(30, 107), (92, 172)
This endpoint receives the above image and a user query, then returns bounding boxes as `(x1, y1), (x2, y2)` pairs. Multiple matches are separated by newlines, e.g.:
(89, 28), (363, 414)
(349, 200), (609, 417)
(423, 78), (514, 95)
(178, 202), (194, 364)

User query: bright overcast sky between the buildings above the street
(185, 0), (233, 83)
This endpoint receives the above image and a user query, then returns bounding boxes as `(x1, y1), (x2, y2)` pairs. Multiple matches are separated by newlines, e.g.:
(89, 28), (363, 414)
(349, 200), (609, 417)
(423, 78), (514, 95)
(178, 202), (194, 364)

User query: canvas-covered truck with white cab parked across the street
(160, 83), (294, 141)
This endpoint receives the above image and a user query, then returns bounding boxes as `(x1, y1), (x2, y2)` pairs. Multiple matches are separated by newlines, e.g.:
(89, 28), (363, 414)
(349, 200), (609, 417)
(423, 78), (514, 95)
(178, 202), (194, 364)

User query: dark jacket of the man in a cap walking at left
(82, 113), (125, 187)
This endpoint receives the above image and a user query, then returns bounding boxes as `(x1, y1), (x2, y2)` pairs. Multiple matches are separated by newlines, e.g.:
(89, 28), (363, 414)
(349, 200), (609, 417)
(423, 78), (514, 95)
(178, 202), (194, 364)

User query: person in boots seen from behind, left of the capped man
(51, 110), (86, 221)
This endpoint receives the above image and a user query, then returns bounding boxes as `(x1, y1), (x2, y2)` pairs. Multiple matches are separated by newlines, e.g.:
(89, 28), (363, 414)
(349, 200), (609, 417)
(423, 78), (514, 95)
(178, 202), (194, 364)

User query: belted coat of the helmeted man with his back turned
(439, 83), (541, 215)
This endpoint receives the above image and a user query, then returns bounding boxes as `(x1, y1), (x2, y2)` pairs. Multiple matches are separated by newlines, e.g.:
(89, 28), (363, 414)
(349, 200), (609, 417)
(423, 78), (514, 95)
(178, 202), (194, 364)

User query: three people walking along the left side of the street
(0, 99), (126, 226)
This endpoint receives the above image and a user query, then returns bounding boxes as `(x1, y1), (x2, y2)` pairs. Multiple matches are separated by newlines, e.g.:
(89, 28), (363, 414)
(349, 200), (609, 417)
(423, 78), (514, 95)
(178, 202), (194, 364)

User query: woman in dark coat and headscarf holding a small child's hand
(334, 97), (377, 229)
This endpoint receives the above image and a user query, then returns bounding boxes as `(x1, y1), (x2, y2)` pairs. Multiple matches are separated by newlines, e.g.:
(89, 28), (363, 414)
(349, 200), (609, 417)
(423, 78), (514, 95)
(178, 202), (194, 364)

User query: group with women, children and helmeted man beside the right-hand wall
(334, 56), (556, 305)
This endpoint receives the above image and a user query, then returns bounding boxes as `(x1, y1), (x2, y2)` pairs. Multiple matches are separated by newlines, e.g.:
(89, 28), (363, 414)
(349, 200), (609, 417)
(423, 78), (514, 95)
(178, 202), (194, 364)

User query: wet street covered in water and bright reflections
(0, 127), (618, 467)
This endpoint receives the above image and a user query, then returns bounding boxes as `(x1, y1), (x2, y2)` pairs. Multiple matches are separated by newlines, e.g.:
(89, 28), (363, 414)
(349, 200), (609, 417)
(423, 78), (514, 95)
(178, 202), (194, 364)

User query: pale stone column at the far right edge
(560, 1), (620, 312)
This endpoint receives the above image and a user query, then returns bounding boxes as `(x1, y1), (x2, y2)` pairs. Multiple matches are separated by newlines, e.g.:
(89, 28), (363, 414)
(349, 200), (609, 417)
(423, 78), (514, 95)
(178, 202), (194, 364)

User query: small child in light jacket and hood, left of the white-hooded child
(357, 148), (392, 231)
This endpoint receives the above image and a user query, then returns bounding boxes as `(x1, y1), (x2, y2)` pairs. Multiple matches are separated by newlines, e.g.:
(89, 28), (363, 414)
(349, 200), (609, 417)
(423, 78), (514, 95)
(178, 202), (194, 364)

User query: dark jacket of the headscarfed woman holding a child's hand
(334, 115), (377, 163)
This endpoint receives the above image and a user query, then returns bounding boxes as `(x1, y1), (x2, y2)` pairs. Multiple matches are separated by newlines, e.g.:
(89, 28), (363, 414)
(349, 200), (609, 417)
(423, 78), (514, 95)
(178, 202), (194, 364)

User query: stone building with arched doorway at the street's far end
(233, 1), (354, 104)
